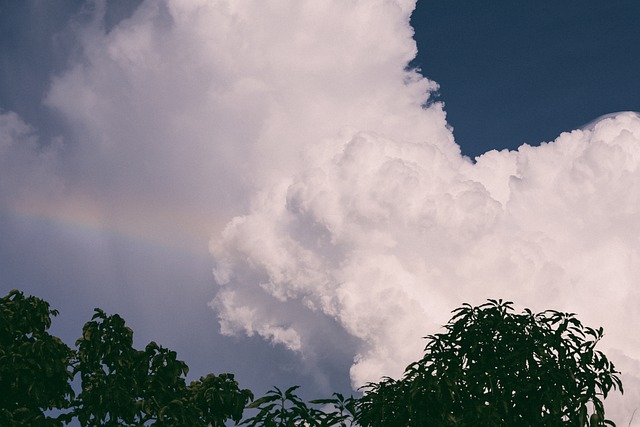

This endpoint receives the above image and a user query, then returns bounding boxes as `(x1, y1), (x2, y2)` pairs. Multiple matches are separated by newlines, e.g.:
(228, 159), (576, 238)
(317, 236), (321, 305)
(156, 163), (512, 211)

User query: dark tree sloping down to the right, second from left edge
(68, 309), (253, 427)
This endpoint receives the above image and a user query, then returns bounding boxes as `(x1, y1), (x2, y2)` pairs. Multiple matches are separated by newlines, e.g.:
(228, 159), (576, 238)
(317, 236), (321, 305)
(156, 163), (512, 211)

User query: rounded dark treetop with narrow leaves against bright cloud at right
(356, 300), (622, 427)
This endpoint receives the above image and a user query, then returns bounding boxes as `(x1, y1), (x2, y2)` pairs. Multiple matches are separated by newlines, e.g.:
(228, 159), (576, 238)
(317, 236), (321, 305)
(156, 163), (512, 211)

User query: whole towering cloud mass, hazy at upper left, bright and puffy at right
(0, 0), (640, 423)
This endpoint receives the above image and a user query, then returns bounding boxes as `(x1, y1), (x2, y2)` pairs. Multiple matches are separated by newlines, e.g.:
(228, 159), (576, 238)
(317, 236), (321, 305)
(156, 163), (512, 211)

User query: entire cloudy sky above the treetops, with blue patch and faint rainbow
(0, 0), (640, 425)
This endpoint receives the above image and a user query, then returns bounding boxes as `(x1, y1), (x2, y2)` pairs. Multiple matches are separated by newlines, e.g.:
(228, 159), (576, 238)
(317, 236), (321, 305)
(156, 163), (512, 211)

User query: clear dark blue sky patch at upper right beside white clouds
(412, 0), (640, 157)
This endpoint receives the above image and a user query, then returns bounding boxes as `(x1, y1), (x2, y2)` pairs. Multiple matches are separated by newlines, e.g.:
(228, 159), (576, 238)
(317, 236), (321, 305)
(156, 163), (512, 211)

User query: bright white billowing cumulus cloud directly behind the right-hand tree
(212, 113), (640, 422)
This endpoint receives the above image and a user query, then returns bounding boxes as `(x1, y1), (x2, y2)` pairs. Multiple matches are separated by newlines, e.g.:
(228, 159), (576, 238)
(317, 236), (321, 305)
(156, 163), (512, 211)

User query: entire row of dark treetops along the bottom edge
(0, 290), (622, 427)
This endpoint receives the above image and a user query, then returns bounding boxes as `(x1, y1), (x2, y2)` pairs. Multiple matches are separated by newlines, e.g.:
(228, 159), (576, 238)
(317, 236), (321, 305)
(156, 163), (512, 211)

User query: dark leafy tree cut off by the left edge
(0, 290), (73, 426)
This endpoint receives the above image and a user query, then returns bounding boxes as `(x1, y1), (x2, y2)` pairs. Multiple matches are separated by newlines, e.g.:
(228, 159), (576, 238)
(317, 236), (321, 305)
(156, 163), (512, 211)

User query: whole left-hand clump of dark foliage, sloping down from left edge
(0, 290), (253, 427)
